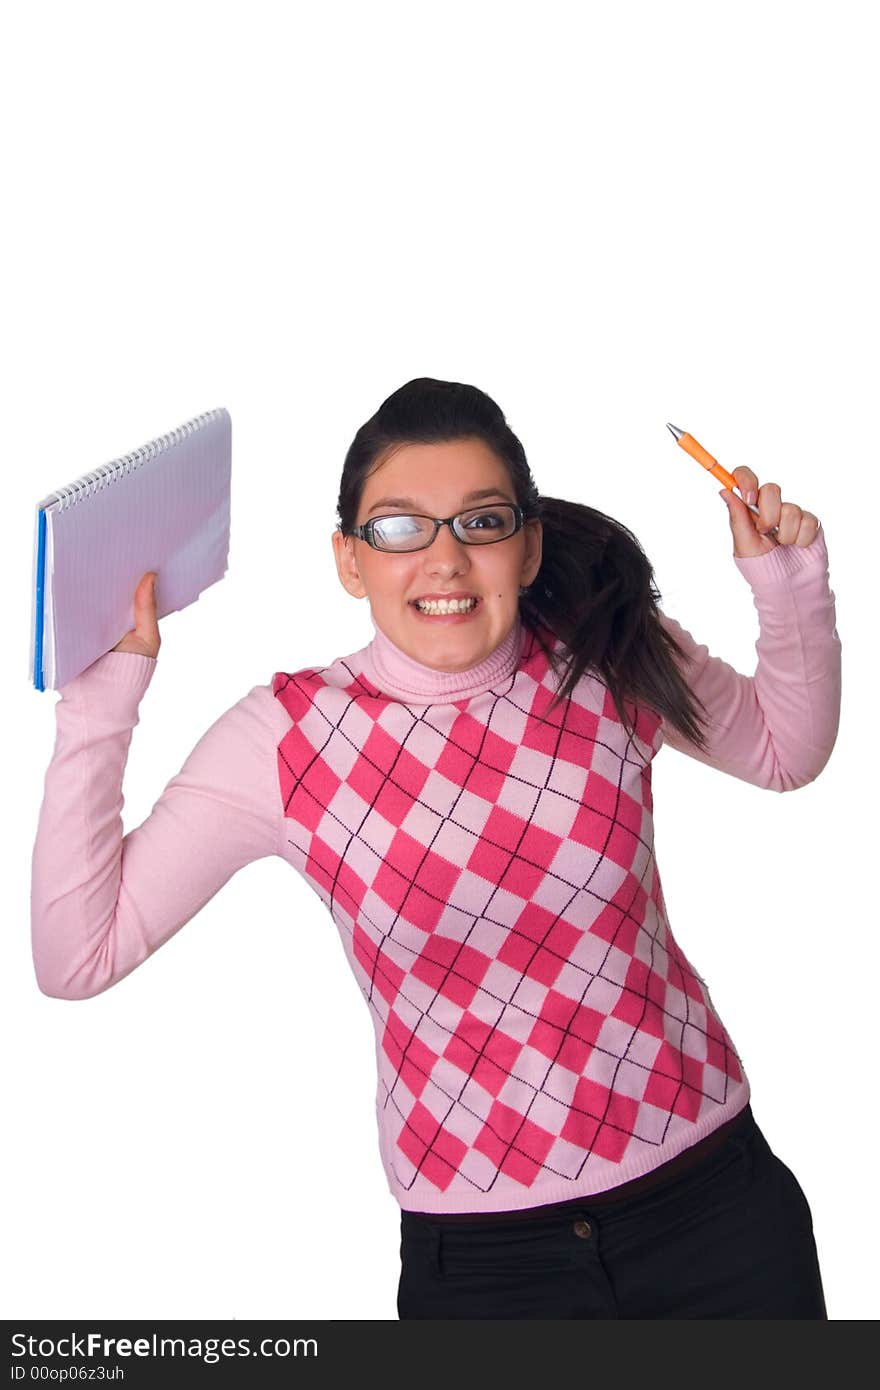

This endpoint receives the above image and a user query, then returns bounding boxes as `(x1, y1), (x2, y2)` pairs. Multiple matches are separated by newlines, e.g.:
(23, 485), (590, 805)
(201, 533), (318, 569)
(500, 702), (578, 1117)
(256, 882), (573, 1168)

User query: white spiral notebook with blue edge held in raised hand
(29, 407), (232, 691)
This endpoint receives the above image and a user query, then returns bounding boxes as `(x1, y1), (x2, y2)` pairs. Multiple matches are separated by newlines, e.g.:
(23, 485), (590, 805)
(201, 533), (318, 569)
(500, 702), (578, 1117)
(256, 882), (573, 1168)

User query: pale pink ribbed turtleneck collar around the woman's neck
(366, 612), (524, 705)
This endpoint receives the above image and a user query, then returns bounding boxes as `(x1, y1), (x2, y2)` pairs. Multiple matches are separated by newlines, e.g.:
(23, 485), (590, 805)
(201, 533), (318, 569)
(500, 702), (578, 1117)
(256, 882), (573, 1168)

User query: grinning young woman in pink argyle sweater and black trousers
(32, 378), (841, 1319)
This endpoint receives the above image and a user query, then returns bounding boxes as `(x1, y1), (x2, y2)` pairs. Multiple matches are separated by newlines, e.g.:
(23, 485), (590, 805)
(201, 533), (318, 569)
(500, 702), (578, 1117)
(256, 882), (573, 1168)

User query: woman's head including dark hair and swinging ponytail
(332, 377), (706, 748)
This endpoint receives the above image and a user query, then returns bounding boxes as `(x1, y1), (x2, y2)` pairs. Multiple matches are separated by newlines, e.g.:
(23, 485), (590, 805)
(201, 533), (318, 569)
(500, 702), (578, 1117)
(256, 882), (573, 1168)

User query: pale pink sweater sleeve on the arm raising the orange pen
(659, 527), (841, 791)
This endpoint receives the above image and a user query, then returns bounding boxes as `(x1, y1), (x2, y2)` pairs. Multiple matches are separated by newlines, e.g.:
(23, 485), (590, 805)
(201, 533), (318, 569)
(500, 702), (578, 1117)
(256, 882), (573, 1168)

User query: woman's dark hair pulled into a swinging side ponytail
(336, 377), (708, 752)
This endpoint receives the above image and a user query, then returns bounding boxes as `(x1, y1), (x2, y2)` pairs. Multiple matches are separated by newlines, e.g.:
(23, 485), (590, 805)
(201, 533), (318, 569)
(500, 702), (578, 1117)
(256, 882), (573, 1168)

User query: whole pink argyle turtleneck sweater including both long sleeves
(32, 531), (841, 1212)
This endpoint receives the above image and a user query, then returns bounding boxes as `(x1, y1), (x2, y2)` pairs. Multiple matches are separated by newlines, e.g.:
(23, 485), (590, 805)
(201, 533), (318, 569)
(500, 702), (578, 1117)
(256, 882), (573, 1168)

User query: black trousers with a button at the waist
(398, 1105), (827, 1319)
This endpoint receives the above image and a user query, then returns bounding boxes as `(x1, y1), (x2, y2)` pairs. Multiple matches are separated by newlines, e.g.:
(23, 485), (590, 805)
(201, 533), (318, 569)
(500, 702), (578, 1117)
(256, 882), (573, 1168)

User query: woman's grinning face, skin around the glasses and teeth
(332, 439), (542, 671)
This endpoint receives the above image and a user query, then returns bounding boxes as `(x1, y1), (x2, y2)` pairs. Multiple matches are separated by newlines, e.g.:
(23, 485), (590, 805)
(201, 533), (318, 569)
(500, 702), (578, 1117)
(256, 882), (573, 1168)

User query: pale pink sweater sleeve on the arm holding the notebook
(31, 652), (289, 999)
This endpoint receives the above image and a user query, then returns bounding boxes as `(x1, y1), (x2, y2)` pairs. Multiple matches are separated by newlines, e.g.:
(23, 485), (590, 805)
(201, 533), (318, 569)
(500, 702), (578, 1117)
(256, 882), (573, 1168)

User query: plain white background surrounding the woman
(0, 0), (880, 1319)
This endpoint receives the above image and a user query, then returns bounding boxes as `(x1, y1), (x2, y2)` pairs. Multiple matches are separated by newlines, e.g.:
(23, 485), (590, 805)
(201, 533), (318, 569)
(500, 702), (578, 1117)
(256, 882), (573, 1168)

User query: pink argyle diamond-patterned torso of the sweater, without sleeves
(272, 630), (749, 1212)
